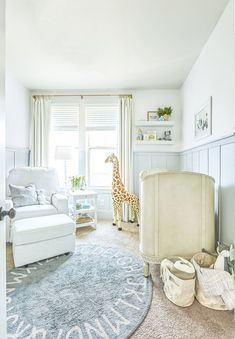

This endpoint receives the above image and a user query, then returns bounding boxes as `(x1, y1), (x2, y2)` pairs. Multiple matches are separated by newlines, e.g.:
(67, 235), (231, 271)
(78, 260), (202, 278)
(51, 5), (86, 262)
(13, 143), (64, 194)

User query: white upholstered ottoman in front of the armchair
(12, 214), (76, 267)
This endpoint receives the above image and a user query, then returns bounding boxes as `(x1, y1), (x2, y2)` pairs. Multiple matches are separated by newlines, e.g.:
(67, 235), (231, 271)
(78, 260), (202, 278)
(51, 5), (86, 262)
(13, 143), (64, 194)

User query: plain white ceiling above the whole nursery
(6, 0), (228, 90)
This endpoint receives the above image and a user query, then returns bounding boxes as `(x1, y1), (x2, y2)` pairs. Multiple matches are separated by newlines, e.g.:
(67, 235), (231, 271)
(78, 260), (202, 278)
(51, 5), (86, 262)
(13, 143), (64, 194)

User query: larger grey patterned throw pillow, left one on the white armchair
(9, 184), (38, 207)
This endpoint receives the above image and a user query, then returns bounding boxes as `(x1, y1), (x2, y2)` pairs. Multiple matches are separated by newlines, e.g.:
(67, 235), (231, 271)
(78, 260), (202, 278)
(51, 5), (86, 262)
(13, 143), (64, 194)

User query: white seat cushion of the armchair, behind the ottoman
(14, 205), (58, 221)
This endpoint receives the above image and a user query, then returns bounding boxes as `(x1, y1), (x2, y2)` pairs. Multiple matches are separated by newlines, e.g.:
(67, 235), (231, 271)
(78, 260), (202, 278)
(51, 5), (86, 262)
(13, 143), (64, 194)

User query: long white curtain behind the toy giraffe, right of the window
(118, 96), (133, 222)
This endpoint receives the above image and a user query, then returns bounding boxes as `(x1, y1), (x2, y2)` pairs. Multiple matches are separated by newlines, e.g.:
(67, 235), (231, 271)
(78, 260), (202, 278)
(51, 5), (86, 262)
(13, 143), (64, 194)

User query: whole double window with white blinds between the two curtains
(50, 96), (119, 188)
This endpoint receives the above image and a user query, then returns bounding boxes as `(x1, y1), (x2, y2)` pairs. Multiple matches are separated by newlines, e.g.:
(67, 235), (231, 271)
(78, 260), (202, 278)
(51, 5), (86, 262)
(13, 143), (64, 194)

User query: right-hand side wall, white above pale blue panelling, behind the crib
(181, 0), (235, 244)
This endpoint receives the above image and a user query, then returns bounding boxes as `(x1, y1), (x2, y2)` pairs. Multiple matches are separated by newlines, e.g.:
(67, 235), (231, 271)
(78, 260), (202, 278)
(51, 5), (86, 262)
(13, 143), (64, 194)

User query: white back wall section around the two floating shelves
(132, 89), (181, 152)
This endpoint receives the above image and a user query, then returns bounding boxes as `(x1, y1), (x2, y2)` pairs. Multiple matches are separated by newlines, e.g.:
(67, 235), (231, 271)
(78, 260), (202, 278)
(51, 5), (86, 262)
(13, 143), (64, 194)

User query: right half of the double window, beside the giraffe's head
(85, 97), (119, 187)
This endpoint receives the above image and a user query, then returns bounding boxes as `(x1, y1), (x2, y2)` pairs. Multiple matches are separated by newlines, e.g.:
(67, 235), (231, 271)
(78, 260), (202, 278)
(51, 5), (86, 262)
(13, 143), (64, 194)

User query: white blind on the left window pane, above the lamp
(51, 102), (79, 131)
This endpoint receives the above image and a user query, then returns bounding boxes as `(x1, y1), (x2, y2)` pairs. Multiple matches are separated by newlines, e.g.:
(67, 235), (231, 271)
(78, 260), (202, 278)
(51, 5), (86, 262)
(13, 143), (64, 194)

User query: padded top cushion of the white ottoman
(12, 214), (75, 245)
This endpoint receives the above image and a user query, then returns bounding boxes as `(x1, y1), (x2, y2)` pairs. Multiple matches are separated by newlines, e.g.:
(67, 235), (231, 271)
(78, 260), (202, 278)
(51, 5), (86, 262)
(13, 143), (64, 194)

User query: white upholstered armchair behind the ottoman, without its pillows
(6, 167), (69, 241)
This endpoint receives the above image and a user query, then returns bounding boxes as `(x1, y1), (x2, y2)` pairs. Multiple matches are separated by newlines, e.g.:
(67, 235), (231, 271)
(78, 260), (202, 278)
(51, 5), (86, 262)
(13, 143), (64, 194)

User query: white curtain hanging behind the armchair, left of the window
(30, 96), (51, 167)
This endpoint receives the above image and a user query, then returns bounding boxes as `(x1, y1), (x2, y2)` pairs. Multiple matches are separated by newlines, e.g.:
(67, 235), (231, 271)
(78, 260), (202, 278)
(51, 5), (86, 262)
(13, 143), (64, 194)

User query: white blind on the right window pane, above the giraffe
(85, 97), (119, 130)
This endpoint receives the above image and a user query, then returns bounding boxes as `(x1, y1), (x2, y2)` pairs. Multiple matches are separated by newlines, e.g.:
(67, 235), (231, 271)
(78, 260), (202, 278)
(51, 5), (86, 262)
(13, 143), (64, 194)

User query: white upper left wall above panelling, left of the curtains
(6, 74), (30, 148)
